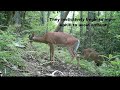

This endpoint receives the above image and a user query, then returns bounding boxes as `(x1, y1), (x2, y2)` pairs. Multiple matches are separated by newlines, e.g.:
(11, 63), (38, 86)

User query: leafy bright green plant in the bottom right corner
(98, 54), (120, 76)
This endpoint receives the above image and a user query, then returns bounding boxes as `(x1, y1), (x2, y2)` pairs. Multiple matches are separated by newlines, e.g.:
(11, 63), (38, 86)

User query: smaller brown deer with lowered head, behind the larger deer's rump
(82, 48), (103, 66)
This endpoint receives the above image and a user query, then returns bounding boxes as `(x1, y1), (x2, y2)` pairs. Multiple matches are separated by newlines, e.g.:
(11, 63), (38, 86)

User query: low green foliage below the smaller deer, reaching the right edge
(73, 55), (120, 76)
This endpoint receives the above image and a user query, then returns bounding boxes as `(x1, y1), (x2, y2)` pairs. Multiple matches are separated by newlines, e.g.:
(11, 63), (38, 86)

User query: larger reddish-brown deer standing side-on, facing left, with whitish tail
(29, 32), (80, 62)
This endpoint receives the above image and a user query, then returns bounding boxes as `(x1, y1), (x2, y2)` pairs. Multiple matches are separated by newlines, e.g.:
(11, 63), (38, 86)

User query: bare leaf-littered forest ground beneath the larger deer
(19, 51), (99, 77)
